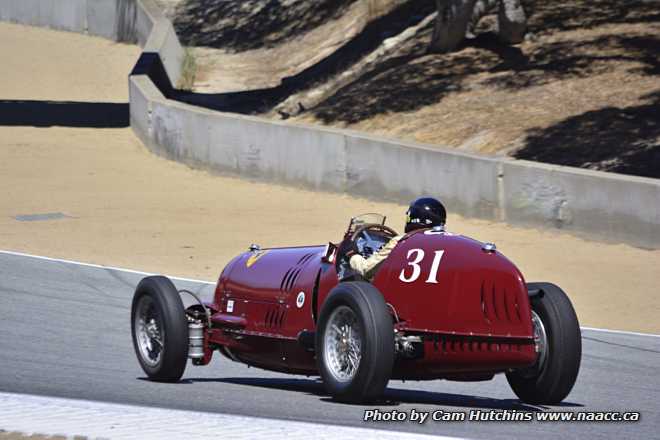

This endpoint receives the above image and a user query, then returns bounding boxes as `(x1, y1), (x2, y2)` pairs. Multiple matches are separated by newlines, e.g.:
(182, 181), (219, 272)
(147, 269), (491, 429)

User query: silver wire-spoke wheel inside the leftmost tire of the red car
(134, 295), (165, 367)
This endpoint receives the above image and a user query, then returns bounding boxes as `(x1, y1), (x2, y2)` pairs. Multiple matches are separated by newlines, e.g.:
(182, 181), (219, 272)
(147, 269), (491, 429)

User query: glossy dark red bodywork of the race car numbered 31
(203, 230), (536, 380)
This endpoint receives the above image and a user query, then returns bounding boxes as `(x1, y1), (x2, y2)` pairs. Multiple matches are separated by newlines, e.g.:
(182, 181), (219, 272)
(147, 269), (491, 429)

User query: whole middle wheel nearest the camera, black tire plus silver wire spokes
(315, 281), (394, 402)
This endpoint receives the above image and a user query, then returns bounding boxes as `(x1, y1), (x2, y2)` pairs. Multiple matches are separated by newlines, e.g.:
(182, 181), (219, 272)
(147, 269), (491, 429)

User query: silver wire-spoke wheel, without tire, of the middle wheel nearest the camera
(323, 306), (363, 382)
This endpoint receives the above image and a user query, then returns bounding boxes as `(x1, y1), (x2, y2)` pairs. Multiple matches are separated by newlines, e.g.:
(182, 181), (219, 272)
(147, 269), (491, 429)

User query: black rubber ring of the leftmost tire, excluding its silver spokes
(131, 276), (188, 382)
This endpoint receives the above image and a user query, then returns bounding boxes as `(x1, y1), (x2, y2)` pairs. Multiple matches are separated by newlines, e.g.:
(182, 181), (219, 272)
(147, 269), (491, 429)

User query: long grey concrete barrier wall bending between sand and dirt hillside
(0, 0), (660, 248)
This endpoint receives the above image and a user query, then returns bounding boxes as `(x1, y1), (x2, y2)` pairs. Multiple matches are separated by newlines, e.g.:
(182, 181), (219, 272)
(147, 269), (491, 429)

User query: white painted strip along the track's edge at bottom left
(0, 393), (461, 440)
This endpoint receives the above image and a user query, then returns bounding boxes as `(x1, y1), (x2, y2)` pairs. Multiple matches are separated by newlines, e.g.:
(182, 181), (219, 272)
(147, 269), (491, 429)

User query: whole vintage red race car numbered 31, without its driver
(131, 214), (582, 404)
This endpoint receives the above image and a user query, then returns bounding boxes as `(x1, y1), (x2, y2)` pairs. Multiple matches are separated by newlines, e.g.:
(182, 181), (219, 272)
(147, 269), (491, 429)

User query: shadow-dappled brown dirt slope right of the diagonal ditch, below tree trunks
(299, 2), (660, 177)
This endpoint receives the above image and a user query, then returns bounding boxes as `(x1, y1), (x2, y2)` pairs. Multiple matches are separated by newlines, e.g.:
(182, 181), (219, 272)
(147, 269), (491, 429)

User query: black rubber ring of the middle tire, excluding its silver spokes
(315, 281), (394, 402)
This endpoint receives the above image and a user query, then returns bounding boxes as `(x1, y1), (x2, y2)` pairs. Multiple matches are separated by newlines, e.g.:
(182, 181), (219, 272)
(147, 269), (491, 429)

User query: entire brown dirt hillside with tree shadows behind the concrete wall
(169, 0), (660, 177)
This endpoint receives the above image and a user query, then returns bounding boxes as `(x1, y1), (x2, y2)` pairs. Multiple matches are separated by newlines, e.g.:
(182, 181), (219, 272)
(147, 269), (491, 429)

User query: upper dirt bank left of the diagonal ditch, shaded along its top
(158, 0), (418, 94)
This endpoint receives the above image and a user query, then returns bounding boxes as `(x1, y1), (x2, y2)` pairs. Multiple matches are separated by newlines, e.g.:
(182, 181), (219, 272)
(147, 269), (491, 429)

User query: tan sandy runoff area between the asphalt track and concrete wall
(0, 23), (660, 333)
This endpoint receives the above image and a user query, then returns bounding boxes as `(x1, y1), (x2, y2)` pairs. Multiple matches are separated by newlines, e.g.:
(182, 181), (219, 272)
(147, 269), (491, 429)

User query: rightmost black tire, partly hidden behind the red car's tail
(506, 283), (582, 405)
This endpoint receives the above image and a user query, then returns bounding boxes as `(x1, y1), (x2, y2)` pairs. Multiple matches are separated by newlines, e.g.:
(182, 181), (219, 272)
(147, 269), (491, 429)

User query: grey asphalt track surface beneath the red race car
(0, 252), (660, 440)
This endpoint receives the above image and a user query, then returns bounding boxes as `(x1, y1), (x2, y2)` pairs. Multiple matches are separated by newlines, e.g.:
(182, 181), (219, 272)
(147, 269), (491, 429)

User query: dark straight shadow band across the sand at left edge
(0, 100), (129, 128)
